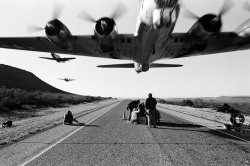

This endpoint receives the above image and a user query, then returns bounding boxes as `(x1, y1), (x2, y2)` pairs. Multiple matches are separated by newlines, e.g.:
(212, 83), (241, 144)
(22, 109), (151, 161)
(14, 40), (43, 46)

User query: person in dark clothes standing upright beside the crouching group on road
(145, 93), (157, 128)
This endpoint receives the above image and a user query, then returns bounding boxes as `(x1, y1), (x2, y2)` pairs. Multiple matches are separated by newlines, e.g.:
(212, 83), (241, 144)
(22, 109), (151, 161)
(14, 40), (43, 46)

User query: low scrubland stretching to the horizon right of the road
(158, 97), (250, 115)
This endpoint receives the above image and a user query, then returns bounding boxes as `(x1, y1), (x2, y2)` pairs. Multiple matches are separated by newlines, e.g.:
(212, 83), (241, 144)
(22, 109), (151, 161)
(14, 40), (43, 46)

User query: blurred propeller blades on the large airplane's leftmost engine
(26, 2), (64, 33)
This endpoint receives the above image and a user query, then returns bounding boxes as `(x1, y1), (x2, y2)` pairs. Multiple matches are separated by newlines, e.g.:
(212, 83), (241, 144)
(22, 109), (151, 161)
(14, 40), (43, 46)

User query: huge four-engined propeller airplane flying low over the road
(0, 0), (250, 73)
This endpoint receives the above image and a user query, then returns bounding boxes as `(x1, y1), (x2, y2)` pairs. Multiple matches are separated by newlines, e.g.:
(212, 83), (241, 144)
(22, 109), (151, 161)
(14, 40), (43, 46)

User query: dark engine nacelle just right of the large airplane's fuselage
(188, 14), (222, 43)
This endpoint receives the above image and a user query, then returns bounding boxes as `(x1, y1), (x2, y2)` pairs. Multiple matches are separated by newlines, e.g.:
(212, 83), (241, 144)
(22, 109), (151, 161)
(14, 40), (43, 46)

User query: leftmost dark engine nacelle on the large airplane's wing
(45, 19), (73, 51)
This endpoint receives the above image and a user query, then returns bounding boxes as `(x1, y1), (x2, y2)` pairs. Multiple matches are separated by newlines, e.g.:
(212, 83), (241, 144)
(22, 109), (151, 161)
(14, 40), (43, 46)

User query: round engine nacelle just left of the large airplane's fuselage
(94, 17), (118, 52)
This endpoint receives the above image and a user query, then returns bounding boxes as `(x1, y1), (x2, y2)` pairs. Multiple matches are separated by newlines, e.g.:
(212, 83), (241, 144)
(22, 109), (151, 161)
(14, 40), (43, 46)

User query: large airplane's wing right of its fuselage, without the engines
(161, 32), (250, 59)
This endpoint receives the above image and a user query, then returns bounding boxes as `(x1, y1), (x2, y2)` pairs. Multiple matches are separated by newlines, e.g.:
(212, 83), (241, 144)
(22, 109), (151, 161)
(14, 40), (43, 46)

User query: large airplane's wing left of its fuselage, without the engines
(0, 34), (135, 60)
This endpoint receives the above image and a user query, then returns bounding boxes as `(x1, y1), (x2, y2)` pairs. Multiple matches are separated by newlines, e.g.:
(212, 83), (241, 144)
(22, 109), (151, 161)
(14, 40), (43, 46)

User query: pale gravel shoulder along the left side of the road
(0, 100), (115, 147)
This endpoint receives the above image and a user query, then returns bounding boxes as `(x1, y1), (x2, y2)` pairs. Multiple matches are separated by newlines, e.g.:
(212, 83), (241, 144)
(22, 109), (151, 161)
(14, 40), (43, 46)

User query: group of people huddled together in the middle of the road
(127, 93), (160, 128)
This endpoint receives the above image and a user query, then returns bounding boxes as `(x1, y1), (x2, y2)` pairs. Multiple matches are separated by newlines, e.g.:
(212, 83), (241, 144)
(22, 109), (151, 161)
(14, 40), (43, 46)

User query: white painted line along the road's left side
(20, 105), (111, 166)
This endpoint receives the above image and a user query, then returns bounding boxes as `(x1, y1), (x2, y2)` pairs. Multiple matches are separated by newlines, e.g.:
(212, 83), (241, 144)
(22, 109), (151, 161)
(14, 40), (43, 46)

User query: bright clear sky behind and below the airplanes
(0, 0), (250, 98)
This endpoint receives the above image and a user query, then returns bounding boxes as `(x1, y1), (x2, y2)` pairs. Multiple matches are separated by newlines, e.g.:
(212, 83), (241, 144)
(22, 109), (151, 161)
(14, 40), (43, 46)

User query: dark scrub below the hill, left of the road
(0, 87), (105, 113)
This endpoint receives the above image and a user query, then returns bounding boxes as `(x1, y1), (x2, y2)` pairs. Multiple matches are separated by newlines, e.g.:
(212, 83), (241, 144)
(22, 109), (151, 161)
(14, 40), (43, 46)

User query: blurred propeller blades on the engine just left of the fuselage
(78, 2), (127, 23)
